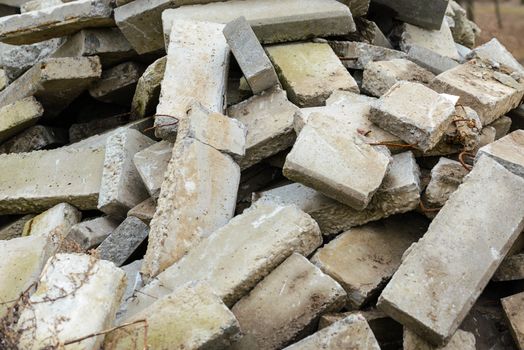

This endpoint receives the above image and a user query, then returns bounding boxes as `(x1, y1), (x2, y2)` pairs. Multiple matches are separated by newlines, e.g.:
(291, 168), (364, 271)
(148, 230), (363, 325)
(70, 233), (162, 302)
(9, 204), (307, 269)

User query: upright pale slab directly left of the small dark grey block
(155, 19), (230, 142)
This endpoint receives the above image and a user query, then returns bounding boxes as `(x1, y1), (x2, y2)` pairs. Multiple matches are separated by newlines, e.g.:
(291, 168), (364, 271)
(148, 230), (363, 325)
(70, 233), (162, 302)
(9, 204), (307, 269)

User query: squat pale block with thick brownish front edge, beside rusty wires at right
(370, 81), (455, 151)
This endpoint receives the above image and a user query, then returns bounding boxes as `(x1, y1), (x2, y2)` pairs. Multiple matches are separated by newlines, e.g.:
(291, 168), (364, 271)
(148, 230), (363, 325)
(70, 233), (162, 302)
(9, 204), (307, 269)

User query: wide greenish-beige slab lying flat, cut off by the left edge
(0, 148), (104, 214)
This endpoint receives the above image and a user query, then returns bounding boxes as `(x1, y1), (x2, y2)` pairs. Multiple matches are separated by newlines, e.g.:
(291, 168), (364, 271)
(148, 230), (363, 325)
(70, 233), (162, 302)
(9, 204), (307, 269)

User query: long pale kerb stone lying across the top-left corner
(0, 0), (115, 45)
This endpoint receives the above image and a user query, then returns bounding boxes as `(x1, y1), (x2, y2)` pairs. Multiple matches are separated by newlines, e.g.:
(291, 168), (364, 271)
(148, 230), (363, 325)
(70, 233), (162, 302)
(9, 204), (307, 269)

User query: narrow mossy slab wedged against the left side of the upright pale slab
(131, 56), (167, 119)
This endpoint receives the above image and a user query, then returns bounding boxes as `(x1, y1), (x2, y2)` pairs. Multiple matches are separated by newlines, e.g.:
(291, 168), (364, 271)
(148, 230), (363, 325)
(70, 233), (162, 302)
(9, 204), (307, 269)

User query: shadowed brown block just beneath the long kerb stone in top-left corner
(51, 28), (136, 67)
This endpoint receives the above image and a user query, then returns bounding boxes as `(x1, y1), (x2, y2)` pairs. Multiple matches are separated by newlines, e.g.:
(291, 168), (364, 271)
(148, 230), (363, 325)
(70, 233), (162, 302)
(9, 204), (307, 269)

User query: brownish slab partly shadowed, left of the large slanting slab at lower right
(311, 216), (427, 310)
